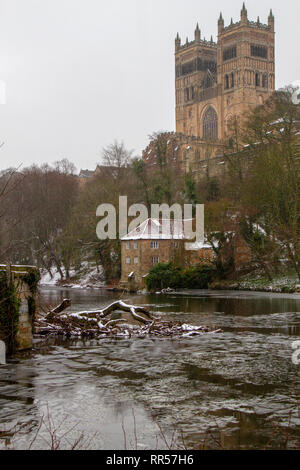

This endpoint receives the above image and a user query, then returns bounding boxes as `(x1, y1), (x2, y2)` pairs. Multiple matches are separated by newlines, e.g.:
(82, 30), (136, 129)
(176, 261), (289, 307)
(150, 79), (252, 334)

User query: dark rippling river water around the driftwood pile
(0, 288), (300, 450)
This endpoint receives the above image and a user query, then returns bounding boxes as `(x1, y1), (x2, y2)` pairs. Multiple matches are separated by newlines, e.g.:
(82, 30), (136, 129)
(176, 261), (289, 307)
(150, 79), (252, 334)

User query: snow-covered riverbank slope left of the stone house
(40, 262), (105, 289)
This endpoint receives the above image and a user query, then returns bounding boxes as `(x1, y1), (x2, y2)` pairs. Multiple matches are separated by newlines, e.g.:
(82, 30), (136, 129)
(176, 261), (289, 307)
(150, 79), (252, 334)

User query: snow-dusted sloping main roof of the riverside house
(121, 218), (196, 241)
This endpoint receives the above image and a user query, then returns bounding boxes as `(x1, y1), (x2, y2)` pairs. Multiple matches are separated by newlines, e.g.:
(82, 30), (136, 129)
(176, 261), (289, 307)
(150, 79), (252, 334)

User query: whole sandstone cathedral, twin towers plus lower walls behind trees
(143, 4), (275, 178)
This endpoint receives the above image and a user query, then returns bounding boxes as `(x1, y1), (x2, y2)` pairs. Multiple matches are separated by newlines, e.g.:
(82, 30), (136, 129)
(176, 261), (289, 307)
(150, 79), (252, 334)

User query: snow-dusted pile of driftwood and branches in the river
(35, 299), (221, 338)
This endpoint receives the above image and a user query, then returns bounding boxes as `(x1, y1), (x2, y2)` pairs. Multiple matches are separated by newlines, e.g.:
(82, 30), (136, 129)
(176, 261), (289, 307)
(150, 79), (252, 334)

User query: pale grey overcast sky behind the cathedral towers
(0, 0), (300, 170)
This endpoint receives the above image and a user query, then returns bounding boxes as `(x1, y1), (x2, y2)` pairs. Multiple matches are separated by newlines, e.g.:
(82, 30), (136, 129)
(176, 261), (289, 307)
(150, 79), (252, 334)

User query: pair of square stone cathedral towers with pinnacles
(175, 4), (275, 141)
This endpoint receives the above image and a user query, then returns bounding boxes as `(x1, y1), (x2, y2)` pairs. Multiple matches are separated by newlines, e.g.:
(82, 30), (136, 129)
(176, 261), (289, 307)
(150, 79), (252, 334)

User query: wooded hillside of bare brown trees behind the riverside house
(0, 89), (300, 283)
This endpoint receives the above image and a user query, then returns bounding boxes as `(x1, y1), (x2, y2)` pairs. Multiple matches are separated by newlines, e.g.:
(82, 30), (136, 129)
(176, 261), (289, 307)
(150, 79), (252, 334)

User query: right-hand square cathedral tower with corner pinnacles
(218, 4), (275, 137)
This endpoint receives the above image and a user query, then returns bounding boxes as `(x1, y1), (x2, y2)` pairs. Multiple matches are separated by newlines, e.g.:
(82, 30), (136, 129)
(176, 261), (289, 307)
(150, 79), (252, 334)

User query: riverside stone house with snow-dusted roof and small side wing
(120, 218), (214, 290)
